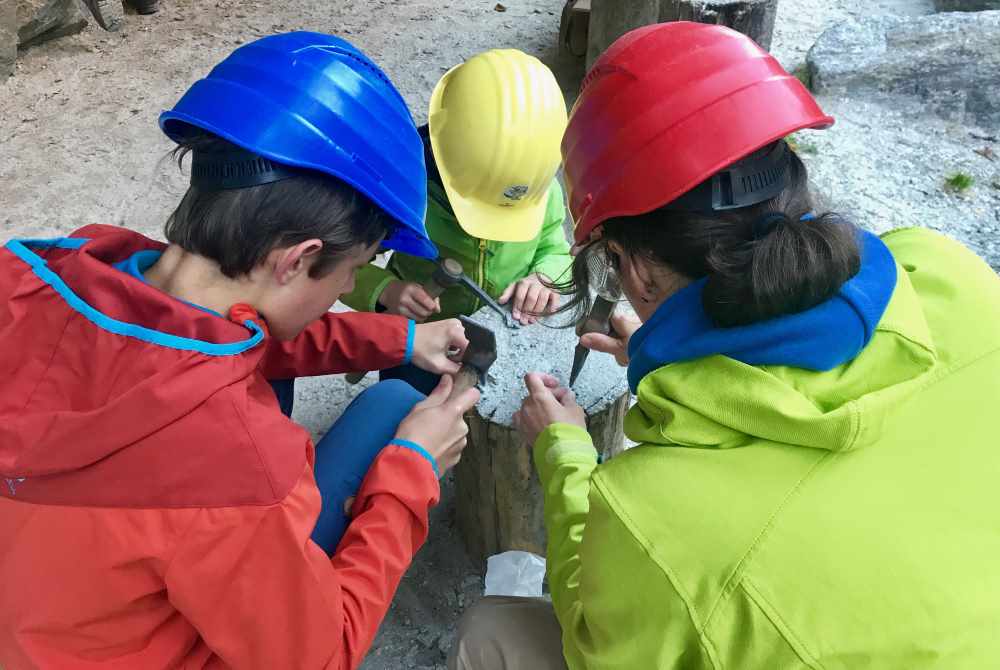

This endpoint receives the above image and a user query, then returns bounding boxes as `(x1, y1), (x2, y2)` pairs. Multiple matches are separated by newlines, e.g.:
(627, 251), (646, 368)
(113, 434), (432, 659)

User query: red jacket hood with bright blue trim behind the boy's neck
(0, 226), (265, 481)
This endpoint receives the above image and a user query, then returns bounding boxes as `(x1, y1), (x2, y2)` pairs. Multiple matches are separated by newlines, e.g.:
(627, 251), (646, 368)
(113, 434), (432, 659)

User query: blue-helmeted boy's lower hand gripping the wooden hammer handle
(396, 375), (479, 475)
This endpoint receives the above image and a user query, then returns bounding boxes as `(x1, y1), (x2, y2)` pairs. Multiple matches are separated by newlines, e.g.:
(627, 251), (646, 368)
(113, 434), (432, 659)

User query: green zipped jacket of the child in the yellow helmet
(341, 180), (572, 320)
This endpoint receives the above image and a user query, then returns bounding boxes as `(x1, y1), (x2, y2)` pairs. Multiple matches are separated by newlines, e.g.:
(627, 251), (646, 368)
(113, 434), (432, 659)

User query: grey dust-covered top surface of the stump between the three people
(472, 307), (628, 426)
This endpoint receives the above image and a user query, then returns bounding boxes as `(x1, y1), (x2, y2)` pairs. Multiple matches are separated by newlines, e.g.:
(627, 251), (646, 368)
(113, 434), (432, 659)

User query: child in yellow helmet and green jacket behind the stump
(342, 49), (571, 389)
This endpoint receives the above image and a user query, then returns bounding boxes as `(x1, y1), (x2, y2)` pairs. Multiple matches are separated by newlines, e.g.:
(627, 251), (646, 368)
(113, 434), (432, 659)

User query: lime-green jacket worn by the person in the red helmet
(534, 229), (1000, 670)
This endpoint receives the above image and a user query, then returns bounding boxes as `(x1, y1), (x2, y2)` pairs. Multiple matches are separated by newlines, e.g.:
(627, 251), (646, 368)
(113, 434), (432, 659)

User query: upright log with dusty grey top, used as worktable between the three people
(455, 311), (631, 561)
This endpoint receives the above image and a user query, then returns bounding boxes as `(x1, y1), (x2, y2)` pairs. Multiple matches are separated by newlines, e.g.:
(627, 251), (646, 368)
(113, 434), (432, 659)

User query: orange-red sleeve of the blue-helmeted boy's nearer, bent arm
(165, 446), (440, 670)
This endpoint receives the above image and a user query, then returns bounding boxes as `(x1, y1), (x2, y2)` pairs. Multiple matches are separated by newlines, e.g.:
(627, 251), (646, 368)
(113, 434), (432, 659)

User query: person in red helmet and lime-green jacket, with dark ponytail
(449, 22), (1000, 670)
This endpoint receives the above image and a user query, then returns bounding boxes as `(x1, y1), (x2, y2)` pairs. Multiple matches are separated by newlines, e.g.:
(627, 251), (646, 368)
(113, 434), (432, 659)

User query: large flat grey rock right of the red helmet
(807, 12), (1000, 127)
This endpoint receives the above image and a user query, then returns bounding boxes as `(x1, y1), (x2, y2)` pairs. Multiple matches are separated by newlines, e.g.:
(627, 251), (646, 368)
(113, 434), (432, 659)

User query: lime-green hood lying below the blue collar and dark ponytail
(625, 238), (937, 451)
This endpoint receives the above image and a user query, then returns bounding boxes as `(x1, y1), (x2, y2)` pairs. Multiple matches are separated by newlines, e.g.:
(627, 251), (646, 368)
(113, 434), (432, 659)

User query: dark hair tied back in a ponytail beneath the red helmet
(552, 144), (861, 327)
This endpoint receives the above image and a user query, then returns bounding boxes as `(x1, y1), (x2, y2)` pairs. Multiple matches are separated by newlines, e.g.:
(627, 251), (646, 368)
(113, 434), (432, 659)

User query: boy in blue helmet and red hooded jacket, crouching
(0, 33), (478, 668)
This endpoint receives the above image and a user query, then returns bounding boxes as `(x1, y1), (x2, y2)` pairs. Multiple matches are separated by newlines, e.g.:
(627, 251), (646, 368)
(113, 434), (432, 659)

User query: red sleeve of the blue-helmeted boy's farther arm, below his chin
(261, 312), (416, 379)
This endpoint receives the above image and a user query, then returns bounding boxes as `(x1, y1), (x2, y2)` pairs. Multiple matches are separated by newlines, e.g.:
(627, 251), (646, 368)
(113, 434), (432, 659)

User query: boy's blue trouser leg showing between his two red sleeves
(312, 380), (424, 555)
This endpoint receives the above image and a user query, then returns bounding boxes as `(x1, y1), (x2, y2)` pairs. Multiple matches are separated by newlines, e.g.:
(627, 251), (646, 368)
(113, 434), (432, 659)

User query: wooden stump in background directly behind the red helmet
(587, 0), (778, 68)
